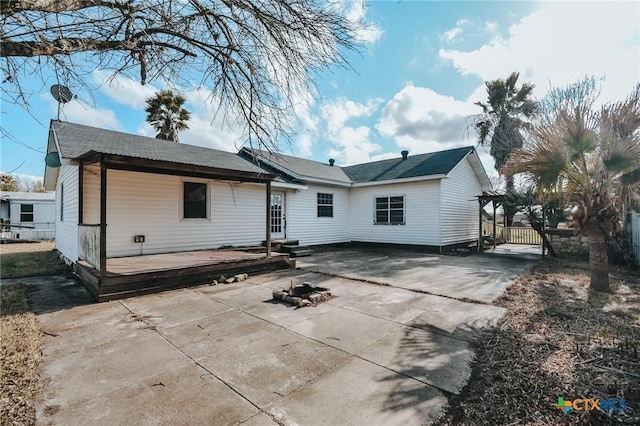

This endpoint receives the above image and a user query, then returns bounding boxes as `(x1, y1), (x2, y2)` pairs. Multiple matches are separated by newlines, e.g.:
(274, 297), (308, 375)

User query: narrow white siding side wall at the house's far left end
(56, 165), (78, 262)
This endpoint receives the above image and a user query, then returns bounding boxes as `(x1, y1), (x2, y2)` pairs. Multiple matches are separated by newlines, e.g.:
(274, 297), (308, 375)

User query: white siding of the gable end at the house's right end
(441, 156), (482, 245)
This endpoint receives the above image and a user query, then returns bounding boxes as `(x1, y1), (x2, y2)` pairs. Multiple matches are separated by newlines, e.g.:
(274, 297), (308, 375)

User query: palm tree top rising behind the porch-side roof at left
(145, 90), (191, 142)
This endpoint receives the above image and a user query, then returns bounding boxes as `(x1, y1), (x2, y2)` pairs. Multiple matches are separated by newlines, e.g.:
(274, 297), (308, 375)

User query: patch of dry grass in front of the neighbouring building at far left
(0, 241), (66, 278)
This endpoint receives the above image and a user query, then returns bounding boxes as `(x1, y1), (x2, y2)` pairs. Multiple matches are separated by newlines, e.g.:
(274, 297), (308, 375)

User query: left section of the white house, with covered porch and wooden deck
(44, 120), (290, 300)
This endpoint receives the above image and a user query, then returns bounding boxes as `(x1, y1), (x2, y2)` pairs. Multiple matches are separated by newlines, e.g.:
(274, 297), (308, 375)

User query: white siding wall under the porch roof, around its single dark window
(103, 170), (266, 257)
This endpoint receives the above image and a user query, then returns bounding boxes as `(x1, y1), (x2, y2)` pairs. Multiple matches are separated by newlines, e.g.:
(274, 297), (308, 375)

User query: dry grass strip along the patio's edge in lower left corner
(0, 285), (42, 425)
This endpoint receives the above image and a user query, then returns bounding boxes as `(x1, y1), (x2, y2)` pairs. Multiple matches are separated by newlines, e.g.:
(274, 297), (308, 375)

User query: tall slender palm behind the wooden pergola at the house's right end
(472, 72), (537, 226)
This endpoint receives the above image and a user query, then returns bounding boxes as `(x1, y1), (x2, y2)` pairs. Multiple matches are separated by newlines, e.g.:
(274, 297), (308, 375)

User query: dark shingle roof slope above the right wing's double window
(342, 146), (474, 183)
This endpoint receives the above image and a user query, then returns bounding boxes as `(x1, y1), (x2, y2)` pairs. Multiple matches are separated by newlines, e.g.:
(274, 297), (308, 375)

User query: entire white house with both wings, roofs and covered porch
(44, 120), (490, 300)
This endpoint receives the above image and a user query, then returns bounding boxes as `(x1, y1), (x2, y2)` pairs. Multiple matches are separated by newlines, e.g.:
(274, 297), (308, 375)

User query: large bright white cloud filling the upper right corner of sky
(439, 2), (640, 101)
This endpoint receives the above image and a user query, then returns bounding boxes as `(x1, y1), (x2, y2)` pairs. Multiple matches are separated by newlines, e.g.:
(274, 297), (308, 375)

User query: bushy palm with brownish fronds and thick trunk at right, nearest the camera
(505, 80), (640, 291)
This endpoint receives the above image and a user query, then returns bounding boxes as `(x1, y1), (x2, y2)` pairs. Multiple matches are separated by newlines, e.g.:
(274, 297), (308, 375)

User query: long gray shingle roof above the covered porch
(51, 120), (265, 174)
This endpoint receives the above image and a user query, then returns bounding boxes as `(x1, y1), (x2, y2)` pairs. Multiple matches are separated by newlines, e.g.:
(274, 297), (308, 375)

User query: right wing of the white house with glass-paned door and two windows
(240, 147), (491, 249)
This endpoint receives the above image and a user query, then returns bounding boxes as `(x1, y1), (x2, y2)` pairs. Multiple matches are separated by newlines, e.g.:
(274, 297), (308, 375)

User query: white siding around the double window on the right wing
(350, 180), (440, 246)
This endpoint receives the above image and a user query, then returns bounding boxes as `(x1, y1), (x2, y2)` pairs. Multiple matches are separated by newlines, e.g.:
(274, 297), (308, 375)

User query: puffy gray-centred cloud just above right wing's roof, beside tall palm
(376, 86), (477, 153)
